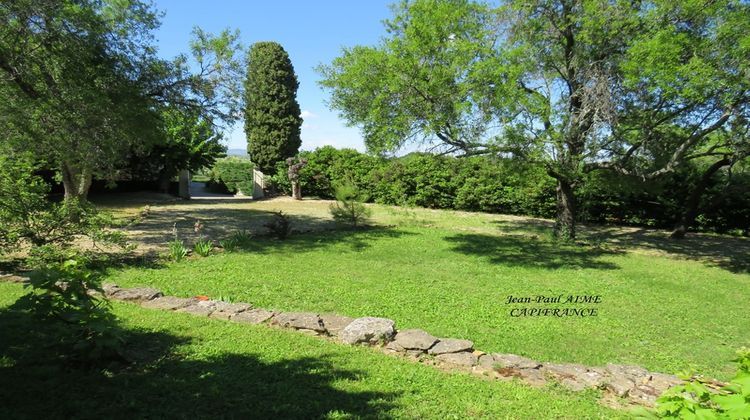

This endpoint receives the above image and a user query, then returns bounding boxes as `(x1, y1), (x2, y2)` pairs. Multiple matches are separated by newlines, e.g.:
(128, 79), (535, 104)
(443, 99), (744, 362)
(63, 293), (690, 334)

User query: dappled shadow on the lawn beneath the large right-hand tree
(446, 233), (619, 270)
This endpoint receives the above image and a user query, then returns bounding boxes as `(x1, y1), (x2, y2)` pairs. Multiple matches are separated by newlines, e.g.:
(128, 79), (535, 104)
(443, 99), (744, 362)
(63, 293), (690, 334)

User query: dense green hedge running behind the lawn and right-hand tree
(272, 146), (750, 235)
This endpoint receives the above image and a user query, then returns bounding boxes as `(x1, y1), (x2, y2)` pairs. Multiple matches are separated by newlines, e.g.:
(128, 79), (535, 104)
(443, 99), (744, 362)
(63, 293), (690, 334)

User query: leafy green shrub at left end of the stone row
(19, 254), (123, 362)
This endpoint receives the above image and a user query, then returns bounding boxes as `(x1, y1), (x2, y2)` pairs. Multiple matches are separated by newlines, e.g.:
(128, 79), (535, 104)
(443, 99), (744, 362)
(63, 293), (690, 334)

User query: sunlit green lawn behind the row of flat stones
(109, 201), (750, 378)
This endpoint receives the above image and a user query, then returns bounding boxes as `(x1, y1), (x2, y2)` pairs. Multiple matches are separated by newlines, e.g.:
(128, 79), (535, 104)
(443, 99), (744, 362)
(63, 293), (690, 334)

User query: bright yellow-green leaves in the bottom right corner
(638, 348), (750, 420)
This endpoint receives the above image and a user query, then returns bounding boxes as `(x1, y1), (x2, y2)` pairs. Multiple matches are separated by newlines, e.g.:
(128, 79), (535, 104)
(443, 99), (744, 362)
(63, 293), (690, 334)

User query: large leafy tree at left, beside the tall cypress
(0, 0), (240, 198)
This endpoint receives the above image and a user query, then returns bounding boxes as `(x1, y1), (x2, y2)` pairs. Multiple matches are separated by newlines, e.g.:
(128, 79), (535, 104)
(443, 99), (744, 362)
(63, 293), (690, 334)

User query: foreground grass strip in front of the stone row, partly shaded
(0, 283), (624, 419)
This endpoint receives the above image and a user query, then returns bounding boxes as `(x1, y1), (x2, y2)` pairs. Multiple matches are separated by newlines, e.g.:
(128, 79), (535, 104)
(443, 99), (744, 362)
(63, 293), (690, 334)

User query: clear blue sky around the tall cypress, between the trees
(149, 0), (392, 151)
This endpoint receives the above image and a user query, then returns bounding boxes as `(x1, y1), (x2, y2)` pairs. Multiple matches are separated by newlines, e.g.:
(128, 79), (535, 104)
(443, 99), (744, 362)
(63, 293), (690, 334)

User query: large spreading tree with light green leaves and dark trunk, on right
(320, 0), (750, 238)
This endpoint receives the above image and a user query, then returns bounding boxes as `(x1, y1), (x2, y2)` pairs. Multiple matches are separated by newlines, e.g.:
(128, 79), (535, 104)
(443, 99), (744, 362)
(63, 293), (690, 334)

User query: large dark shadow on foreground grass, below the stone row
(0, 302), (396, 418)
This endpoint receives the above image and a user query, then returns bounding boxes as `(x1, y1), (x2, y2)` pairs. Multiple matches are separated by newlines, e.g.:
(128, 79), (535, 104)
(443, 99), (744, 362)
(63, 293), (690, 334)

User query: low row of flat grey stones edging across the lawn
(1, 276), (682, 406)
